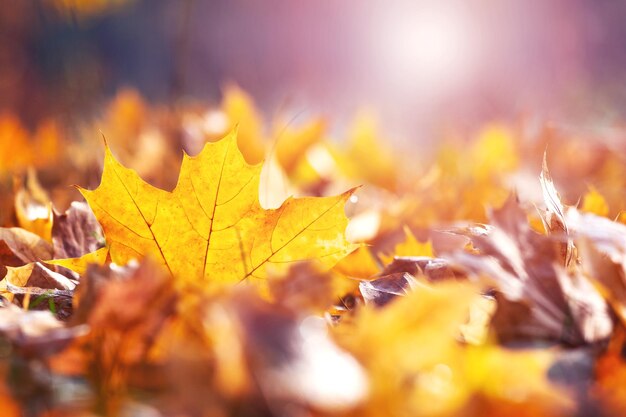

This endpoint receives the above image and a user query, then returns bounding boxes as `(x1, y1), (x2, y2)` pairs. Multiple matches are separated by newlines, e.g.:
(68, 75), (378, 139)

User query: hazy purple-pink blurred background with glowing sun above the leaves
(0, 0), (626, 144)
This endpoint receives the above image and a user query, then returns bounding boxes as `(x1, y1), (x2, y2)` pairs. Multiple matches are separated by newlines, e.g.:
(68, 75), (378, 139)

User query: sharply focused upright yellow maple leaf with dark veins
(80, 131), (354, 284)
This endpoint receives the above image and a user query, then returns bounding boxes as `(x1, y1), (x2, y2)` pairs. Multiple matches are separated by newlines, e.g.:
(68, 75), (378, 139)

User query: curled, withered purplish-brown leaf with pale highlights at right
(451, 196), (612, 345)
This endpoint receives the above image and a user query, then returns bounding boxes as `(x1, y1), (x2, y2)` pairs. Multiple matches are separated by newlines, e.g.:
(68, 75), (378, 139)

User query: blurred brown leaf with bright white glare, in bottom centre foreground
(227, 293), (368, 412)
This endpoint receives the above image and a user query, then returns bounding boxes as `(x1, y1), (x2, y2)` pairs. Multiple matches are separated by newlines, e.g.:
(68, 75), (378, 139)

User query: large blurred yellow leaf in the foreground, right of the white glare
(332, 282), (571, 417)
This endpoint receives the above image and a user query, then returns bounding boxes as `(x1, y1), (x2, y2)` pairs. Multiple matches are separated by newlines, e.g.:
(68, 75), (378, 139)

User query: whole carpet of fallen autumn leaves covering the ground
(0, 87), (626, 417)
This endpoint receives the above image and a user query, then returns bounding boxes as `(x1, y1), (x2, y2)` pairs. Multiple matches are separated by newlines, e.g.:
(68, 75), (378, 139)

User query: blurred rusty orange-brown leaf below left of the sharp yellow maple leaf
(55, 262), (177, 415)
